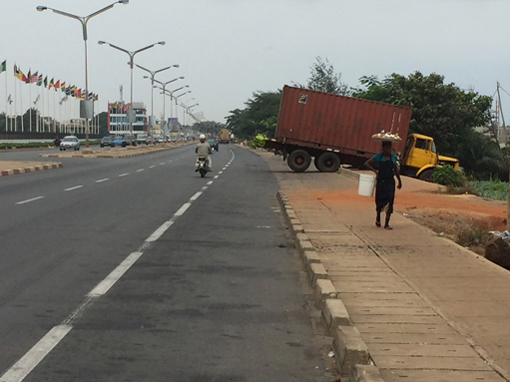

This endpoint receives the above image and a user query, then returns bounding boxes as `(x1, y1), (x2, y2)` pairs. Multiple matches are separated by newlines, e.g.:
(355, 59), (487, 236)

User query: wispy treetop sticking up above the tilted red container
(301, 57), (349, 95)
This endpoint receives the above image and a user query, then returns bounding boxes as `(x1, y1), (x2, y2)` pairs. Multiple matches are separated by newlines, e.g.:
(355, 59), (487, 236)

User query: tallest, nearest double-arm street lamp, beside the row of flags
(36, 0), (129, 149)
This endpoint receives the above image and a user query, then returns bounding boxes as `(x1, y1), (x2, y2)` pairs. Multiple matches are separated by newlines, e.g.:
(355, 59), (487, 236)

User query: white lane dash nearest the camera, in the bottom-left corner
(0, 325), (72, 382)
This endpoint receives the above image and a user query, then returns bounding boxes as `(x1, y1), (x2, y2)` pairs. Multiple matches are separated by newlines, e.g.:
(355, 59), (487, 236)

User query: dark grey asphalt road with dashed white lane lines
(0, 145), (331, 382)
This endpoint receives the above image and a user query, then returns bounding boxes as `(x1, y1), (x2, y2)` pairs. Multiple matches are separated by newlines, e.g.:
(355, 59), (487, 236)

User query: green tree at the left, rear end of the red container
(227, 90), (282, 139)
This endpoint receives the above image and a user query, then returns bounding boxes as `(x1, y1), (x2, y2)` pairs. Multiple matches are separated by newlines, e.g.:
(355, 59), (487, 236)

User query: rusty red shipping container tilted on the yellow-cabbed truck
(266, 86), (412, 171)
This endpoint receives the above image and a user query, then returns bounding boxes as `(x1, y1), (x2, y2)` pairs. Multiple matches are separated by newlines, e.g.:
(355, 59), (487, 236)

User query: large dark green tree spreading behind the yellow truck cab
(353, 71), (494, 176)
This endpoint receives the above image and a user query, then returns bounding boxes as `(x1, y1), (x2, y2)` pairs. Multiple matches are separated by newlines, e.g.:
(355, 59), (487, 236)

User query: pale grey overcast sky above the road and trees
(0, 0), (510, 122)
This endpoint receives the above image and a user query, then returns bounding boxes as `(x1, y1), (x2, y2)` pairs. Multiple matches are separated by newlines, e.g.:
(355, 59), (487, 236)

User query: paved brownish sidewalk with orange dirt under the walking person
(258, 152), (510, 382)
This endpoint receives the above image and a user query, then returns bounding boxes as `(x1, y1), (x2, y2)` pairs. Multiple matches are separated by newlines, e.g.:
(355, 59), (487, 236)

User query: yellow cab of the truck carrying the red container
(400, 134), (459, 182)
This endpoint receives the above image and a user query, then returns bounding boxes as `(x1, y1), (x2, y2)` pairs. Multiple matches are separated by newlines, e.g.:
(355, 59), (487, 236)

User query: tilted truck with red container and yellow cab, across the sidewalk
(265, 86), (459, 180)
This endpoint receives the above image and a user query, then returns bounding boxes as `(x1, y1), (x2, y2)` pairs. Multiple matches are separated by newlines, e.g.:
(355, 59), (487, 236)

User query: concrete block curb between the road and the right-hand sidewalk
(276, 191), (384, 382)
